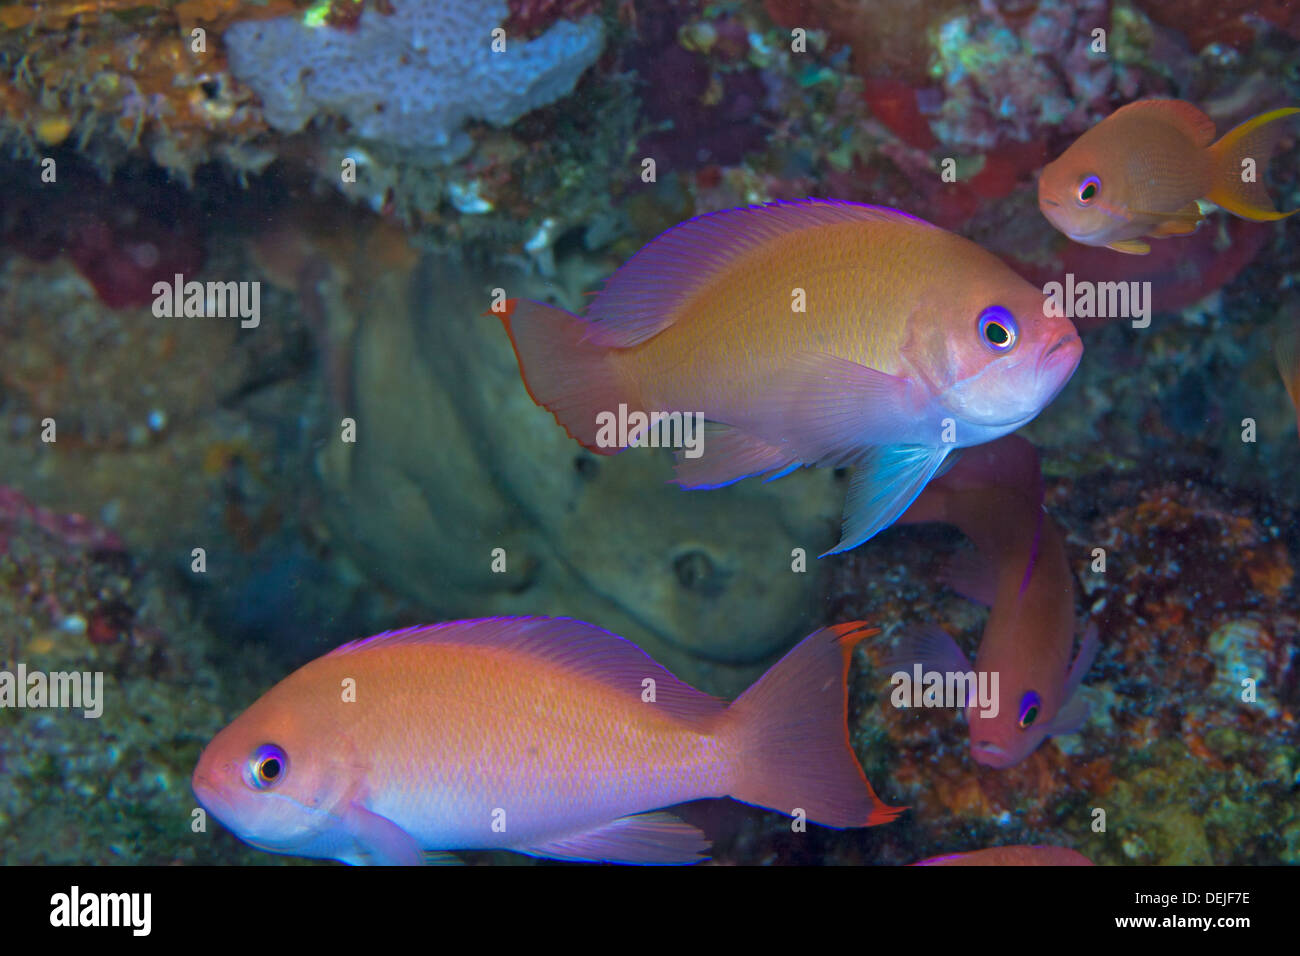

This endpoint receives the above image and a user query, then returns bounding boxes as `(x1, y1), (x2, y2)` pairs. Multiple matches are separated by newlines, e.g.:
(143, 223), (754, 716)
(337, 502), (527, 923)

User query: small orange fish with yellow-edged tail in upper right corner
(1039, 99), (1300, 255)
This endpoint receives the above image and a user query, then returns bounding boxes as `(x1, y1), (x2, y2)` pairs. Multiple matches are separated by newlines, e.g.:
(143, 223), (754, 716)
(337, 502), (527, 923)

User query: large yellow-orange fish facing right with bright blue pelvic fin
(502, 199), (1083, 553)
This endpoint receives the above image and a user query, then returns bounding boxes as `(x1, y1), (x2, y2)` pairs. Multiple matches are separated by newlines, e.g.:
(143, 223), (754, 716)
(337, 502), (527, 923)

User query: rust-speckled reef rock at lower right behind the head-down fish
(795, 472), (1300, 864)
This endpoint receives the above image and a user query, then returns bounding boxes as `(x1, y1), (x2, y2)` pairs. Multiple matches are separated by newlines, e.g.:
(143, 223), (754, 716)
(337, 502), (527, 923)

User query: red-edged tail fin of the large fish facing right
(494, 299), (638, 455)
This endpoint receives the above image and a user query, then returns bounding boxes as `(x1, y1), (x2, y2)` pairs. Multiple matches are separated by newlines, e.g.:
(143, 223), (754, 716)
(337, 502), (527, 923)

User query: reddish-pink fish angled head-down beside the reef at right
(892, 436), (1100, 767)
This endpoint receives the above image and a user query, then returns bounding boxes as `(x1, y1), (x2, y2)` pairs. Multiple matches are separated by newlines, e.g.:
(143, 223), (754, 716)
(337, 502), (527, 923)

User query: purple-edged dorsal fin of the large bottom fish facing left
(325, 618), (727, 730)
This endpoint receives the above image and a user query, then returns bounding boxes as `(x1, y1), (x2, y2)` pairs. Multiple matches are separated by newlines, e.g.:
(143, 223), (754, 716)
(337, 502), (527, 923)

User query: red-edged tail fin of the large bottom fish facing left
(727, 622), (906, 827)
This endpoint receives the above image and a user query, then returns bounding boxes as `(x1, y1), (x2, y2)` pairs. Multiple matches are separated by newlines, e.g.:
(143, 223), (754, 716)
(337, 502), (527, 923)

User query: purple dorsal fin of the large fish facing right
(584, 199), (935, 349)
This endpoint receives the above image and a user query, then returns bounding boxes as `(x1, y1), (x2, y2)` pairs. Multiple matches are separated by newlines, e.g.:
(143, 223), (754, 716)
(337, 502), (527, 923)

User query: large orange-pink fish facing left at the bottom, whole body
(192, 618), (901, 864)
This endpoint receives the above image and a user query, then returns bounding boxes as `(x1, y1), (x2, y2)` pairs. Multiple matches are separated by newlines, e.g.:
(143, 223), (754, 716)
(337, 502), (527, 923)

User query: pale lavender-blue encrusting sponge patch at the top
(224, 0), (603, 164)
